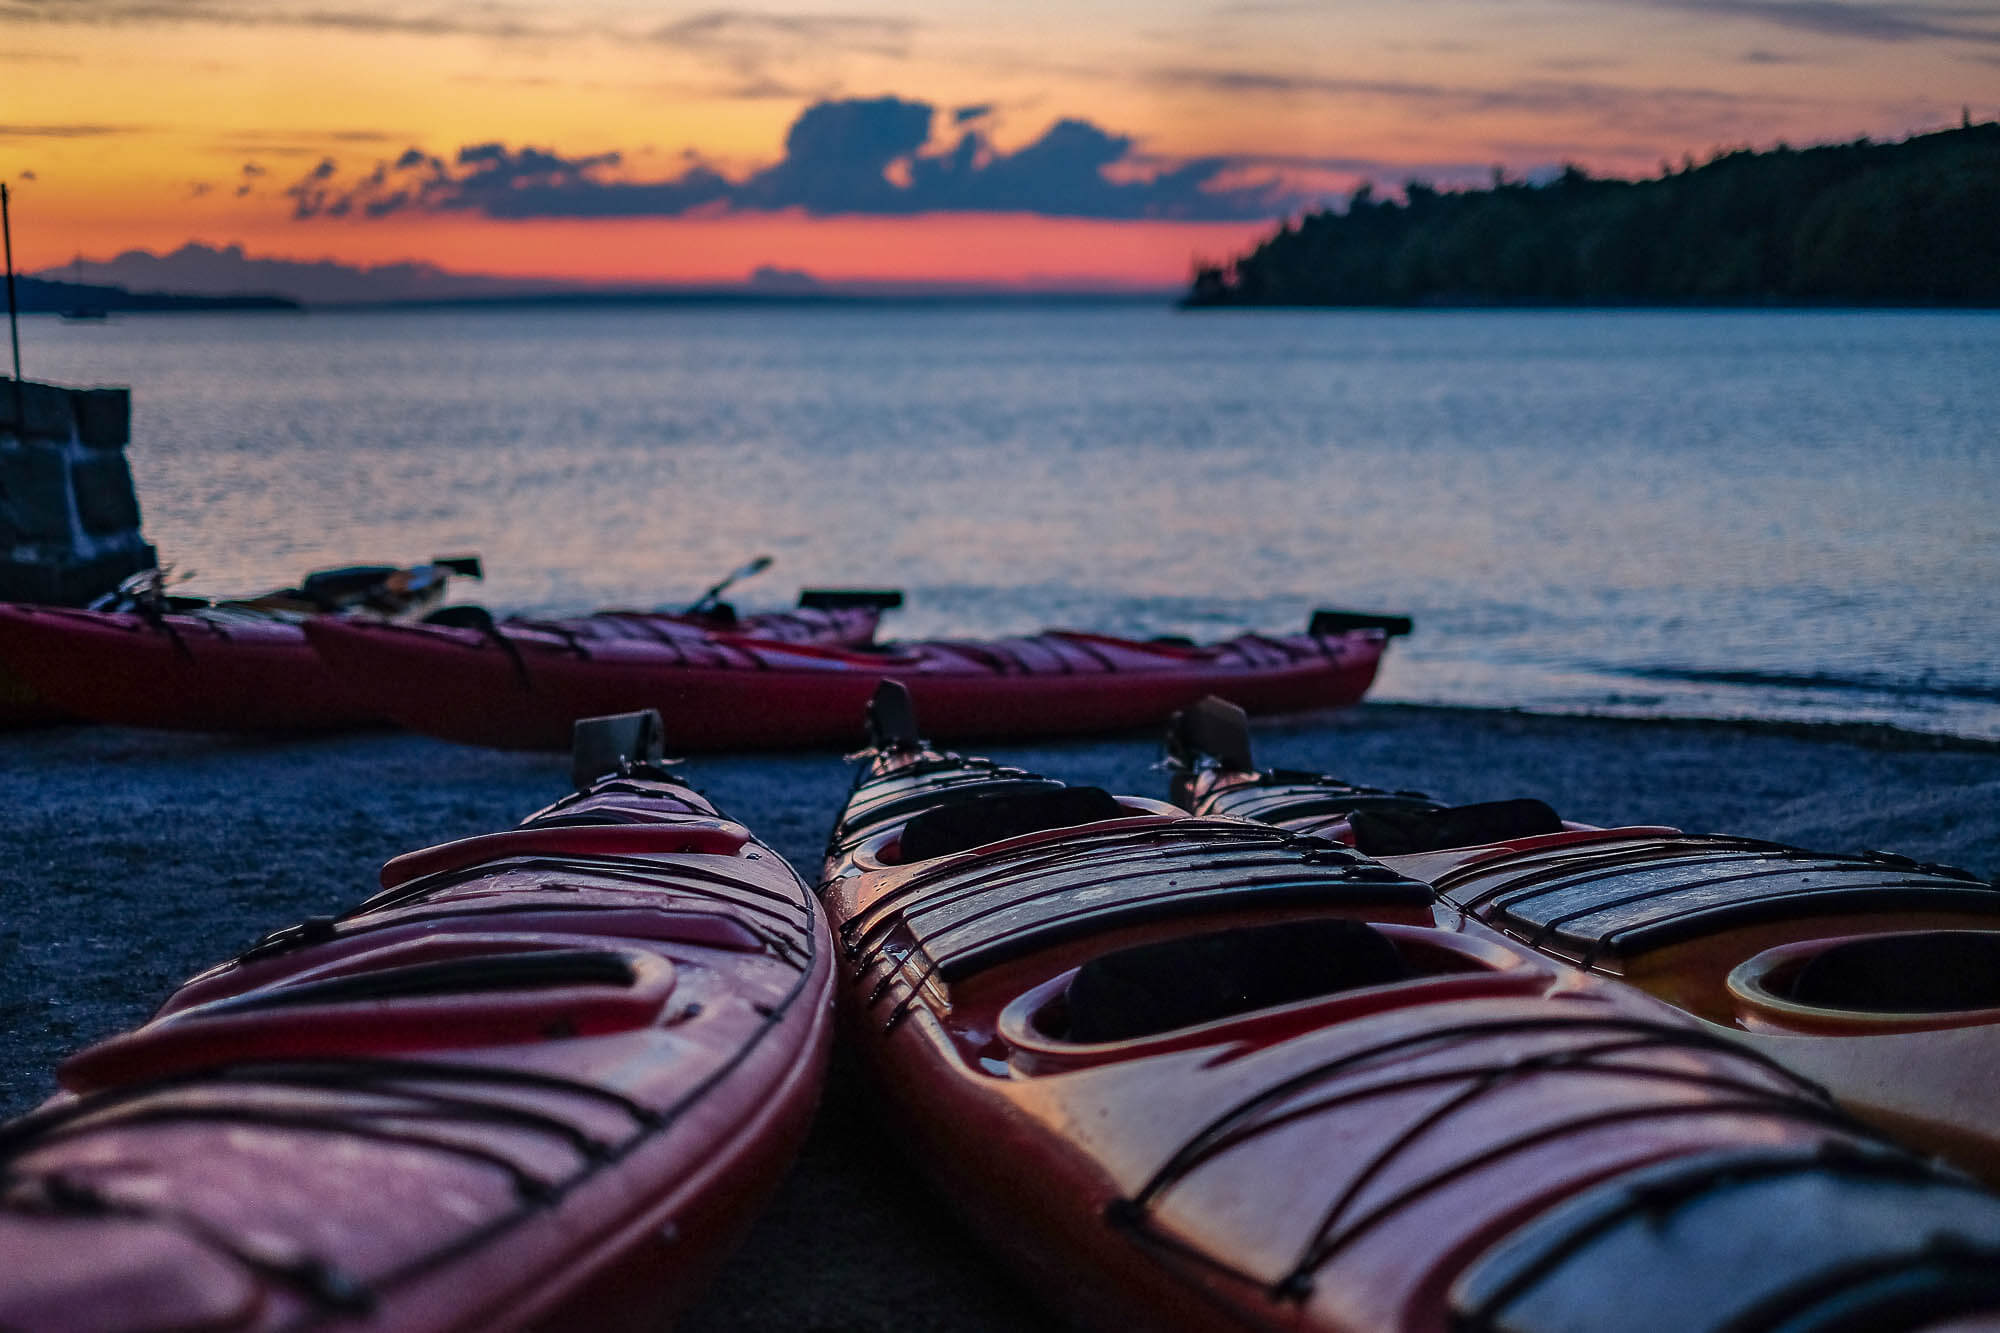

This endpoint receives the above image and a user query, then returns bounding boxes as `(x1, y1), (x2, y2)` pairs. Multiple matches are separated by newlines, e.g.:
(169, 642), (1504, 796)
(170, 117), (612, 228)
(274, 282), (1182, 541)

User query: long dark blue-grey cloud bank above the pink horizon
(286, 98), (1308, 220)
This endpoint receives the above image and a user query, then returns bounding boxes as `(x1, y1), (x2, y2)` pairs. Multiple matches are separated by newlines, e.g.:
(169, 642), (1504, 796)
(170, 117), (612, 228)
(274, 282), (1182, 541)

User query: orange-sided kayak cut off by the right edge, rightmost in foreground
(1168, 701), (2000, 1185)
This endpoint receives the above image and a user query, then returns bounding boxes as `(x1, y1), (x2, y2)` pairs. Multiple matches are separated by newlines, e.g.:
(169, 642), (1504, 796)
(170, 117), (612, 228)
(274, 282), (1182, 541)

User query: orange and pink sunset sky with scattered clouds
(0, 0), (2000, 284)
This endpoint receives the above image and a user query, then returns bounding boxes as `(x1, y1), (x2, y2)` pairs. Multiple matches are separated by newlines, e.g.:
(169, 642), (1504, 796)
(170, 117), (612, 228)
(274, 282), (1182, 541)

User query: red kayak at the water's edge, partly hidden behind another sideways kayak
(0, 580), (882, 732)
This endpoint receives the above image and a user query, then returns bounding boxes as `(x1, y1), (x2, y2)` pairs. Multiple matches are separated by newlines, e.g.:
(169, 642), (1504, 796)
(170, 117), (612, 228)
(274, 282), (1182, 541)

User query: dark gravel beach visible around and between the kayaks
(0, 705), (2000, 1333)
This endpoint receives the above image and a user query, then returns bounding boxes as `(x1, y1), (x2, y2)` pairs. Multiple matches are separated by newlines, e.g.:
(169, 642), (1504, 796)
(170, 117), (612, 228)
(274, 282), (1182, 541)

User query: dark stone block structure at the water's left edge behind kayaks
(0, 378), (156, 604)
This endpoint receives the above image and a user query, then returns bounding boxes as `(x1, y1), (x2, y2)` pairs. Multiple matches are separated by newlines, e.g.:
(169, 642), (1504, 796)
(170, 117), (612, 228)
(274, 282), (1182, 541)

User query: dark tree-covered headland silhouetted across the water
(1182, 122), (2000, 306)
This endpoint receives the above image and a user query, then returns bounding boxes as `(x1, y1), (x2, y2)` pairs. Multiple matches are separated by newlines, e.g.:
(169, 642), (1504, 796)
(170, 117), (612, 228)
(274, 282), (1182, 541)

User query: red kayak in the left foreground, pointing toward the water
(0, 719), (832, 1331)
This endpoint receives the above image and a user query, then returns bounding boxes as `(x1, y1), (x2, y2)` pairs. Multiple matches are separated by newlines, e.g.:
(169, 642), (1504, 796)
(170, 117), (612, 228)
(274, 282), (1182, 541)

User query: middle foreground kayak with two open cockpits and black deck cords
(822, 684), (2000, 1333)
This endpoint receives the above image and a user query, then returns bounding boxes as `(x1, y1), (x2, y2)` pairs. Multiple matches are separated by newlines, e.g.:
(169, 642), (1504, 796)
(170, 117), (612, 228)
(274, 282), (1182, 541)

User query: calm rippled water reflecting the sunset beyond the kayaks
(24, 308), (2000, 737)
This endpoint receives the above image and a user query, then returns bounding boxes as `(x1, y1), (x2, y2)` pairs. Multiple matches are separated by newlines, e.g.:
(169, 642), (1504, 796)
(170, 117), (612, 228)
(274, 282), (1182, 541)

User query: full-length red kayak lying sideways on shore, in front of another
(306, 612), (1408, 751)
